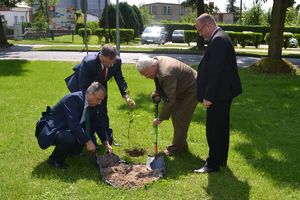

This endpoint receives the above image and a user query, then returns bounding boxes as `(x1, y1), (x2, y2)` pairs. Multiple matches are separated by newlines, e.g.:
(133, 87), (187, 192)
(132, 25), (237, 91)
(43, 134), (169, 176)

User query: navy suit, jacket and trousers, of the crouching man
(35, 91), (107, 162)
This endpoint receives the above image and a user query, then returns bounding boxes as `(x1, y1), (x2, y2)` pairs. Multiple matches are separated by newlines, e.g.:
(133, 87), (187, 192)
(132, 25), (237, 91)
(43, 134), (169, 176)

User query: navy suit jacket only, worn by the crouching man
(36, 91), (106, 149)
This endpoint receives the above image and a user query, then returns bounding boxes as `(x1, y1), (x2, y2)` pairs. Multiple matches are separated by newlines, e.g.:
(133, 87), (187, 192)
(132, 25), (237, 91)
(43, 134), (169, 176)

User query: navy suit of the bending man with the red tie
(65, 53), (127, 141)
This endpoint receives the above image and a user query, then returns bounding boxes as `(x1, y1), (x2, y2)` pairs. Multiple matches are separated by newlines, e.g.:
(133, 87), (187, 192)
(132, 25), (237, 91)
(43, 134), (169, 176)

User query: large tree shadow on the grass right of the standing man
(231, 71), (300, 188)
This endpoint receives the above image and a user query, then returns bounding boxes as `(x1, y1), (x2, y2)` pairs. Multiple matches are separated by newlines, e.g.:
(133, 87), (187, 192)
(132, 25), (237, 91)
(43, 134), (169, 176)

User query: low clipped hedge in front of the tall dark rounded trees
(78, 28), (134, 44)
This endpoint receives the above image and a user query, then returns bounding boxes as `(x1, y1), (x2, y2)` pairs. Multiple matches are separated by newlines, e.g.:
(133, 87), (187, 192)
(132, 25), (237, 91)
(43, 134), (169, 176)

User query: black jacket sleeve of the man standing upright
(204, 37), (226, 102)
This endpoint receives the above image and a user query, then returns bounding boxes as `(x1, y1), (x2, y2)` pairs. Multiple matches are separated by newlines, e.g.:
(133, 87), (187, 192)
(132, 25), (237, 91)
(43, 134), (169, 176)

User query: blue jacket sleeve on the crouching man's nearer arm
(63, 97), (90, 144)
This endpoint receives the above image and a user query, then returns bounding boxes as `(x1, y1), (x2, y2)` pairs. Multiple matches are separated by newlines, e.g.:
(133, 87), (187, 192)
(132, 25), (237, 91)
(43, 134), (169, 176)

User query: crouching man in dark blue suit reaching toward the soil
(35, 82), (112, 169)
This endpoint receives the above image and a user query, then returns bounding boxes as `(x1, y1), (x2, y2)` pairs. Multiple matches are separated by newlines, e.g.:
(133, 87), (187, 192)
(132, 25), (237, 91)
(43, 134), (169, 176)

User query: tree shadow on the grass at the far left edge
(0, 60), (28, 77)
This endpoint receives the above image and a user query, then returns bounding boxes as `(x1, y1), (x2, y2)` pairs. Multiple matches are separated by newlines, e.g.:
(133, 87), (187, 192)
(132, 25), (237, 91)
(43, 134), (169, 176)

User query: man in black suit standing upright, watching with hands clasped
(194, 13), (242, 173)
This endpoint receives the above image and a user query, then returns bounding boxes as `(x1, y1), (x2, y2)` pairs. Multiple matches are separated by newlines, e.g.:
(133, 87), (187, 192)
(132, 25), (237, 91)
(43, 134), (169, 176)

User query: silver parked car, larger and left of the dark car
(141, 26), (167, 44)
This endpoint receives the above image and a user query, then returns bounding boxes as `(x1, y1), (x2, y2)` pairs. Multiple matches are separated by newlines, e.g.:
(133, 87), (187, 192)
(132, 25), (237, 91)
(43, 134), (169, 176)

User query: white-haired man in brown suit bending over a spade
(136, 56), (198, 156)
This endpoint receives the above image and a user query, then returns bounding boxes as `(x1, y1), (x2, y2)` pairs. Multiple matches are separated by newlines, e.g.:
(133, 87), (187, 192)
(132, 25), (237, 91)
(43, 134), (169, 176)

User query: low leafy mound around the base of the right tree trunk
(249, 58), (300, 75)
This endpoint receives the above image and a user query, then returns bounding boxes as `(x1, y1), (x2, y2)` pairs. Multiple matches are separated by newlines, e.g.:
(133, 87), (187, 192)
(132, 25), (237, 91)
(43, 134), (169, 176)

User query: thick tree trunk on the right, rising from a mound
(268, 0), (288, 59)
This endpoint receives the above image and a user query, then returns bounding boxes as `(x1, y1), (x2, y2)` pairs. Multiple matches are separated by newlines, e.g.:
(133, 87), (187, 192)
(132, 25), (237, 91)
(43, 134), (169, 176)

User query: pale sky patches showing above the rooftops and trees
(116, 0), (300, 12)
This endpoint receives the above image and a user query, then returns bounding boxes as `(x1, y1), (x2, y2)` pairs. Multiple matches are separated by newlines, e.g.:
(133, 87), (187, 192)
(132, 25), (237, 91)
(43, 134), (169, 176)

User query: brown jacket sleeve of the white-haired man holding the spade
(159, 76), (177, 120)
